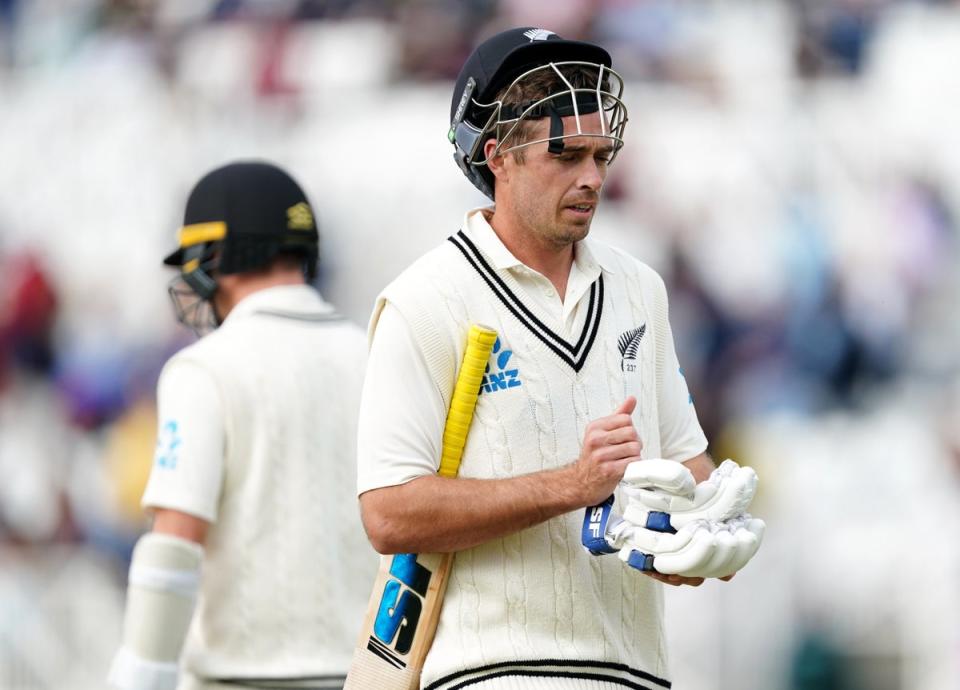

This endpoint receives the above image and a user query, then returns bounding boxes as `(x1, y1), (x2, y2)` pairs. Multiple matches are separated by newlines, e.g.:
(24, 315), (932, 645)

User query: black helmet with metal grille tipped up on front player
(447, 27), (627, 199)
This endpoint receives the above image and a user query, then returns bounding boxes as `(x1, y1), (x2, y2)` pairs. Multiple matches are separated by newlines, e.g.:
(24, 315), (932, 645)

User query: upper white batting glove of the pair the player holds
(621, 459), (757, 532)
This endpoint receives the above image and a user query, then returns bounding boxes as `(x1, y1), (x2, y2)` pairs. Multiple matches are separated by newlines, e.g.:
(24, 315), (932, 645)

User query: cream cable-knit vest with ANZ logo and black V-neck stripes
(380, 233), (684, 690)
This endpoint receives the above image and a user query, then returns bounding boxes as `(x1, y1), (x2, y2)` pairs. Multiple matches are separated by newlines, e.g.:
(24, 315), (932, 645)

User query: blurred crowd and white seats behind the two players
(0, 0), (960, 690)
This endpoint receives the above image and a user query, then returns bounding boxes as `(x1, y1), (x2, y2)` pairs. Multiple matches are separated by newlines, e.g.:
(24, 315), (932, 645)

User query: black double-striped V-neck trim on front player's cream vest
(447, 230), (603, 372)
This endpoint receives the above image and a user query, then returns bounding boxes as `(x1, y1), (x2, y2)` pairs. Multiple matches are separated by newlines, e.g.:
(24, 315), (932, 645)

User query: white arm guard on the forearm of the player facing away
(108, 532), (203, 690)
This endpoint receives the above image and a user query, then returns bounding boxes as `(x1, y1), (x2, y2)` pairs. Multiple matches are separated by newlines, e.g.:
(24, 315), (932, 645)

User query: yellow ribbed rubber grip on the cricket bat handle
(439, 324), (497, 477)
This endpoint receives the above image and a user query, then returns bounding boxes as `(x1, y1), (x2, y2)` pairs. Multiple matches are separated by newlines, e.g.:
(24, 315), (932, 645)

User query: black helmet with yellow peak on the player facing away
(163, 161), (319, 334)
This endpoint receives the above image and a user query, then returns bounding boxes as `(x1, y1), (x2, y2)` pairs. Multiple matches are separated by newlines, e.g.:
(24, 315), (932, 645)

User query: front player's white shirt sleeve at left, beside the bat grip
(357, 302), (446, 494)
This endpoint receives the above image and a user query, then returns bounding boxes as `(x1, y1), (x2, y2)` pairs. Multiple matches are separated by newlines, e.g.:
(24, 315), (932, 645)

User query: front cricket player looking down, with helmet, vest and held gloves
(358, 27), (759, 690)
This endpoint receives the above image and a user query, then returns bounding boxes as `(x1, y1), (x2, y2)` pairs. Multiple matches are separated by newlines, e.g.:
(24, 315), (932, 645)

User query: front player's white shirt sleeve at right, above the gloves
(657, 322), (707, 462)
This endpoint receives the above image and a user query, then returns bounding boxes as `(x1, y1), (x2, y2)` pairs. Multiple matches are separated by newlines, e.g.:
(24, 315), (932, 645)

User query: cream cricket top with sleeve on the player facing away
(143, 286), (377, 688)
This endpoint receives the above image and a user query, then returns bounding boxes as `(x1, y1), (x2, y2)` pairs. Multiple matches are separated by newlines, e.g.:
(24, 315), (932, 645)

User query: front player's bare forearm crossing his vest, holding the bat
(360, 465), (587, 553)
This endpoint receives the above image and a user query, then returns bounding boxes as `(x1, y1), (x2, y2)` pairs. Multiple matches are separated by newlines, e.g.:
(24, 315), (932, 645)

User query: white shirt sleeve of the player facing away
(141, 359), (225, 522)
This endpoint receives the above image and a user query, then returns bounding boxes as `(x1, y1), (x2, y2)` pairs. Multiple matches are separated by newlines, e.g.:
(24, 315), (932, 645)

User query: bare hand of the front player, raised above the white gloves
(574, 395), (643, 506)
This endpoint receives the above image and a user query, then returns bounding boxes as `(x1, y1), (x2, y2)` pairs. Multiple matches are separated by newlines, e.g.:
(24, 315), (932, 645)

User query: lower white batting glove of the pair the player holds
(609, 515), (766, 577)
